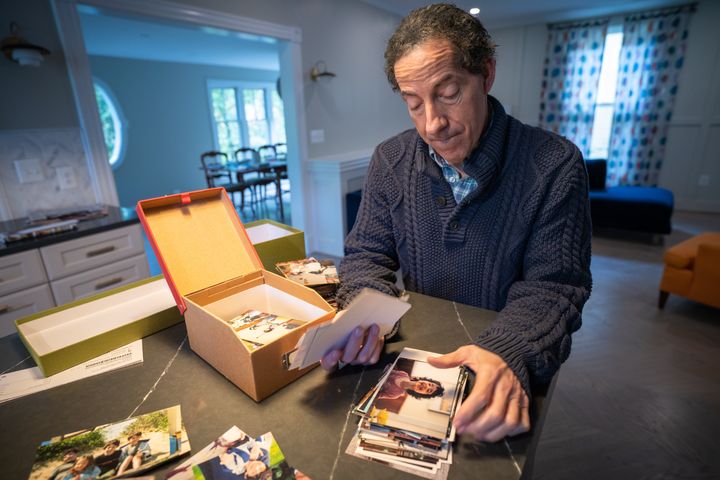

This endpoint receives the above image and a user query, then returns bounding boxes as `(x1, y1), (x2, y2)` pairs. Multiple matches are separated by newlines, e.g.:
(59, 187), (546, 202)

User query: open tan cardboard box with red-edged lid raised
(137, 188), (335, 401)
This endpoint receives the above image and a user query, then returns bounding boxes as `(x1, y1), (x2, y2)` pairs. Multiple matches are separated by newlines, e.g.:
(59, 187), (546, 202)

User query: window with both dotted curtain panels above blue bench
(540, 6), (694, 186)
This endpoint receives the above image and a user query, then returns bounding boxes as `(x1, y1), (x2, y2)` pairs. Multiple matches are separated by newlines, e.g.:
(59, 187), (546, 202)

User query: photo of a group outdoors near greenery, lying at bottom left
(29, 405), (190, 480)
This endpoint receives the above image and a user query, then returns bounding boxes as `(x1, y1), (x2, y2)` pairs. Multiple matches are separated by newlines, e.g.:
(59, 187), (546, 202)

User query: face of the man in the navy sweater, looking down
(395, 40), (495, 167)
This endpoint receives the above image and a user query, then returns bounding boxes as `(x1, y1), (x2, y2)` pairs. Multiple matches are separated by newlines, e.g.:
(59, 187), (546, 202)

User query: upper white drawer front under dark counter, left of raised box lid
(40, 225), (145, 281)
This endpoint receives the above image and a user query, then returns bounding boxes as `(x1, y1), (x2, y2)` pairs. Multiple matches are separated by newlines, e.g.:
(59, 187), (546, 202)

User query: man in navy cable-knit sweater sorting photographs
(322, 5), (591, 441)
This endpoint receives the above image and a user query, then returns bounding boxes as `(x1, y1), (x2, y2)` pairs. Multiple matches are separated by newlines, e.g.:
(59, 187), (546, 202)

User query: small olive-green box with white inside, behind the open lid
(245, 220), (306, 273)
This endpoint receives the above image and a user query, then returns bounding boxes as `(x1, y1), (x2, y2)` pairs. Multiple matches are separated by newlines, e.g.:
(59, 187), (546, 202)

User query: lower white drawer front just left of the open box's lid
(50, 253), (150, 305)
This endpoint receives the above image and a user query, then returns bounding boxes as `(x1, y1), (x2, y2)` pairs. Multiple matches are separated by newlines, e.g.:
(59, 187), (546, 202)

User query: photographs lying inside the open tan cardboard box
(227, 310), (305, 350)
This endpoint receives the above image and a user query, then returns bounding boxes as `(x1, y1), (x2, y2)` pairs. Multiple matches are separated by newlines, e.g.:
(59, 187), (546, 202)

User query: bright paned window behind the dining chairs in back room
(208, 81), (286, 158)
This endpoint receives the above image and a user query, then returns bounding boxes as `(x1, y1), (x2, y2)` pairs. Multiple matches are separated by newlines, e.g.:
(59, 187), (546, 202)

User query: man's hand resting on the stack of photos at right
(428, 345), (530, 442)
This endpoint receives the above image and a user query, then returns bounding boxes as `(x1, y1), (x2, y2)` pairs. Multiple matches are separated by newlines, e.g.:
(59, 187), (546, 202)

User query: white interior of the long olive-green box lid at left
(18, 278), (175, 356)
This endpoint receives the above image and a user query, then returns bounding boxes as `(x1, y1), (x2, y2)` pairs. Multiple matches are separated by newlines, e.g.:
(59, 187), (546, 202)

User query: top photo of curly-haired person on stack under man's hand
(369, 349), (464, 439)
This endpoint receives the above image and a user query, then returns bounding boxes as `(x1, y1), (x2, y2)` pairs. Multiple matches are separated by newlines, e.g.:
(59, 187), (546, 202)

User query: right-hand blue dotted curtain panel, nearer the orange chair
(607, 7), (693, 186)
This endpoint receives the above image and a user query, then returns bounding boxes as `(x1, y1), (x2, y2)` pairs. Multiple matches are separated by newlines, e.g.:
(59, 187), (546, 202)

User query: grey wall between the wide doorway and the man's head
(171, 0), (412, 159)
